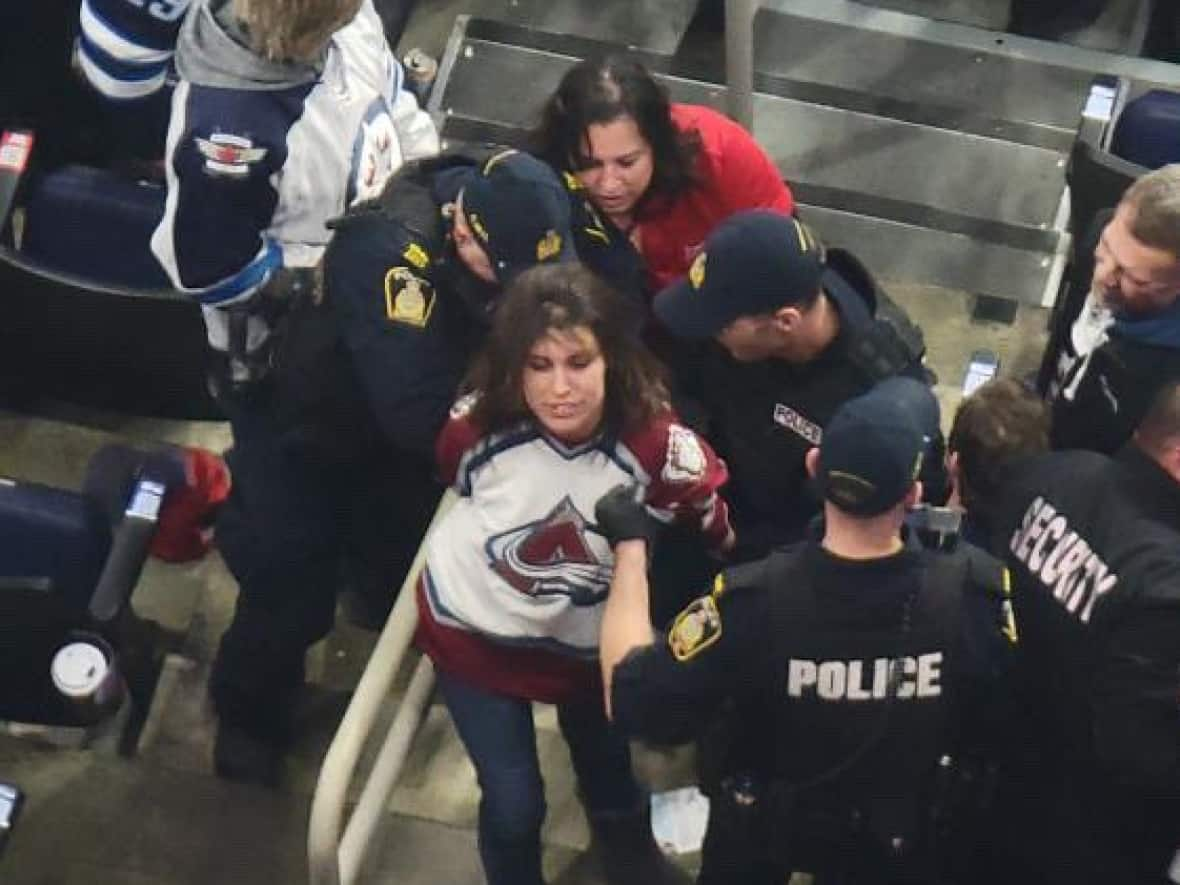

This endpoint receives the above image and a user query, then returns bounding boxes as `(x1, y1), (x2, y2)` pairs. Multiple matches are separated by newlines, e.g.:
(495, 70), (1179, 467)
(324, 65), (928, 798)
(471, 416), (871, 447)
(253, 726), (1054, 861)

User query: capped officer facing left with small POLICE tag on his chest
(655, 210), (945, 558)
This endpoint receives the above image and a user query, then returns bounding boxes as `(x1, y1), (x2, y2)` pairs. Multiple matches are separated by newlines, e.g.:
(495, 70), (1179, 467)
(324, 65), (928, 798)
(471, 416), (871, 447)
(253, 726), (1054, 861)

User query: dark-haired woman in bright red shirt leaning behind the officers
(533, 57), (794, 293)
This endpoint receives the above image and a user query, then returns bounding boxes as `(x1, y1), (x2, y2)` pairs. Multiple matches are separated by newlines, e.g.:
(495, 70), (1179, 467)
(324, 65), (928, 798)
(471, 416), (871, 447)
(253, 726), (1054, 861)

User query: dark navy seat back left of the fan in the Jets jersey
(21, 166), (170, 289)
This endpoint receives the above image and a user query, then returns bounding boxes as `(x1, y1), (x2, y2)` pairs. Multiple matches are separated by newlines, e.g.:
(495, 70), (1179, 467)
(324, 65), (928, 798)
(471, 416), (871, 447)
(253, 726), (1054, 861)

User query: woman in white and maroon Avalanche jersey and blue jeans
(418, 263), (732, 885)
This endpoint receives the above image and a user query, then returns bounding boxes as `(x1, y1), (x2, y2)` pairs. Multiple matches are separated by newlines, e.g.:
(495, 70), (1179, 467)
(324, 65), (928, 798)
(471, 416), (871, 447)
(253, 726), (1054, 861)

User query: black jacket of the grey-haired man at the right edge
(1042, 210), (1180, 454)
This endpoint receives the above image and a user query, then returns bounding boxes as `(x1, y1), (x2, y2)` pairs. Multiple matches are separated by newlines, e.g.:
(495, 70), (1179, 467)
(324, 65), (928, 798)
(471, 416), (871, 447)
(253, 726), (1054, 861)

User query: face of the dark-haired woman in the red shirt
(577, 114), (655, 221)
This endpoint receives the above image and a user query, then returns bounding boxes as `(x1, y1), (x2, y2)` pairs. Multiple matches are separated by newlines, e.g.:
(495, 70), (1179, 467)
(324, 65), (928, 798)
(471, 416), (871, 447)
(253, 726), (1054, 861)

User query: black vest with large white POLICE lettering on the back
(763, 552), (968, 860)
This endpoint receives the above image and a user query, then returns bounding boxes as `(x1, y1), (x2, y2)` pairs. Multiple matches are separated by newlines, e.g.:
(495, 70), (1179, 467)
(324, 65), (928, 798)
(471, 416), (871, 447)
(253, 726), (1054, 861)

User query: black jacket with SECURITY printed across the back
(997, 452), (1180, 885)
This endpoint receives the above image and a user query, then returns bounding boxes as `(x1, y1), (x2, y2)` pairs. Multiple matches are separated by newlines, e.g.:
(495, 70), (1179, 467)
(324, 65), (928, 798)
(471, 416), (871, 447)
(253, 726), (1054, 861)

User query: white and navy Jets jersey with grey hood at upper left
(151, 0), (438, 349)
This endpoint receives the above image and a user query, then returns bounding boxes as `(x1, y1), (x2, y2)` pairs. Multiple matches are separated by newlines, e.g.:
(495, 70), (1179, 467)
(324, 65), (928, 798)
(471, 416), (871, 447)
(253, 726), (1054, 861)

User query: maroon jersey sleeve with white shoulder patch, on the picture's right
(624, 412), (730, 548)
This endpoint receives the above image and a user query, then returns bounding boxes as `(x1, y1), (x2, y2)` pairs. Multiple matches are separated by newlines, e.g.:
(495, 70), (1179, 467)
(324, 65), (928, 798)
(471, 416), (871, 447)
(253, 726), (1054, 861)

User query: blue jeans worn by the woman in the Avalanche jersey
(438, 671), (645, 885)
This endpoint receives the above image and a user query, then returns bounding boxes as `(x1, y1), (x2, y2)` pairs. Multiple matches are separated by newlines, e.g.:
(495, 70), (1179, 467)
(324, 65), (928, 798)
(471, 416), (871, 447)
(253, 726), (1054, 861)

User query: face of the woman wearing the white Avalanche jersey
(522, 326), (607, 445)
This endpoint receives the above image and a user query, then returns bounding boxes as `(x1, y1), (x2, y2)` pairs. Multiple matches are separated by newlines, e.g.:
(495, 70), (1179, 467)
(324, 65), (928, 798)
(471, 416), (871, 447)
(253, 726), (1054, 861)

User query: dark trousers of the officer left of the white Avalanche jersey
(210, 387), (440, 741)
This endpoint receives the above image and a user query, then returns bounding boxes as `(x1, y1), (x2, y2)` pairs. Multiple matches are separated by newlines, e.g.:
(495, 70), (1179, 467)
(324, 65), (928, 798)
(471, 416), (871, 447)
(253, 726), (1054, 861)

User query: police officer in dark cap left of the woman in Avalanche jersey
(210, 151), (585, 784)
